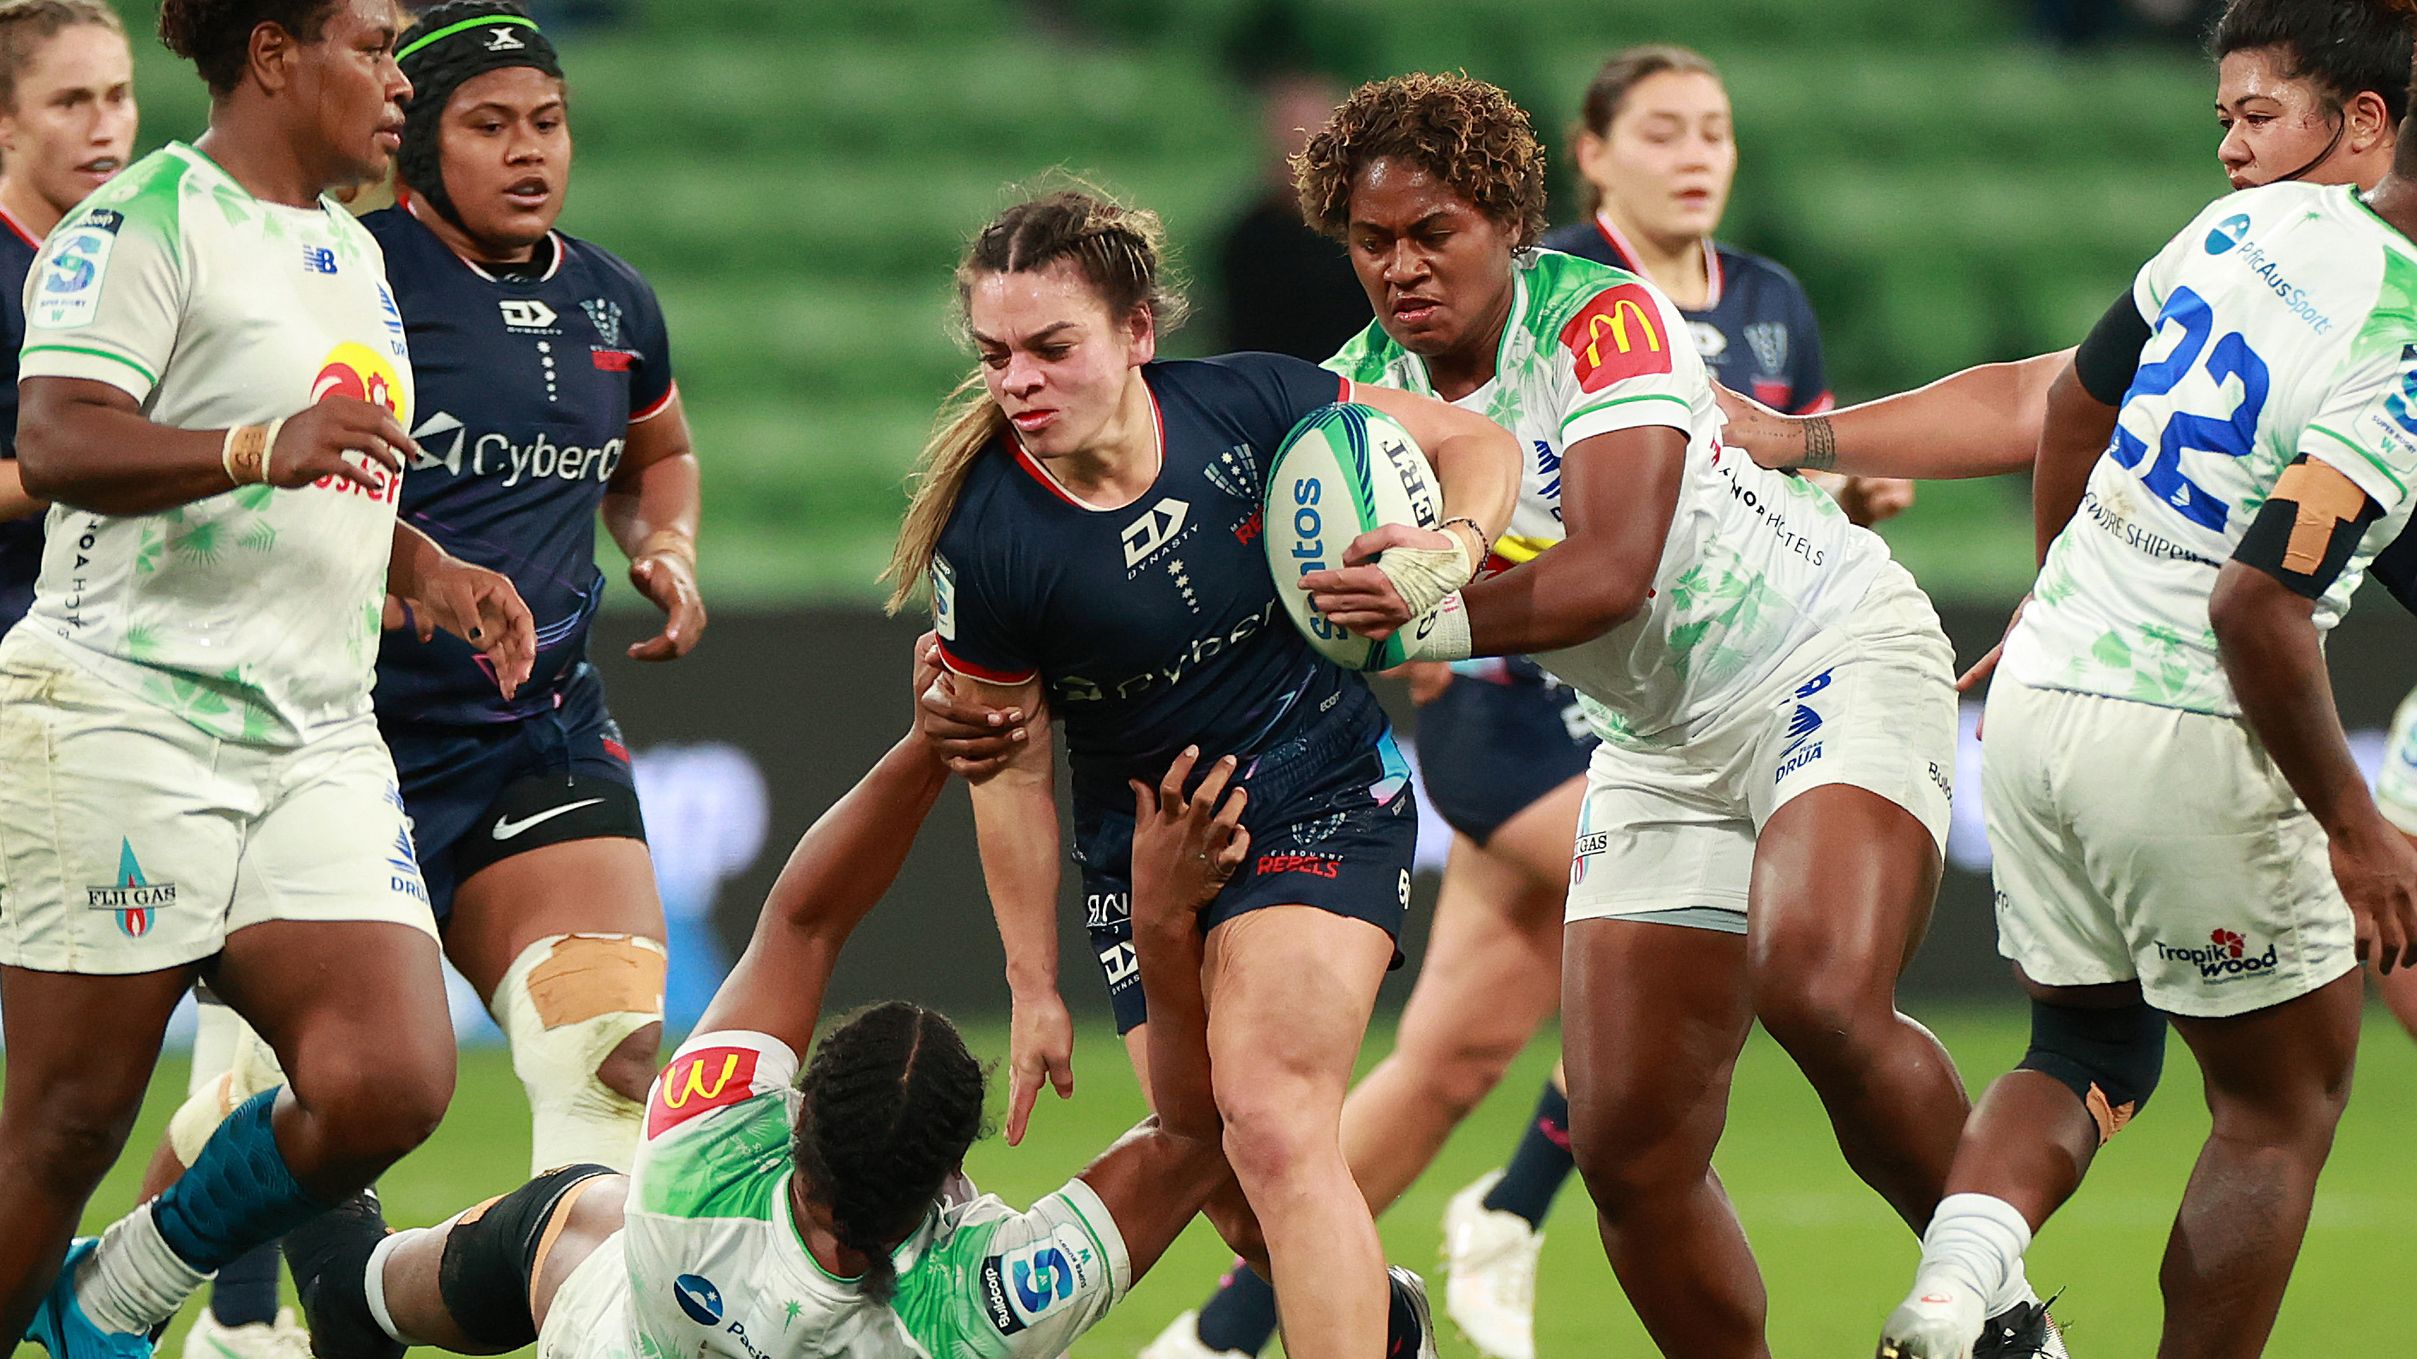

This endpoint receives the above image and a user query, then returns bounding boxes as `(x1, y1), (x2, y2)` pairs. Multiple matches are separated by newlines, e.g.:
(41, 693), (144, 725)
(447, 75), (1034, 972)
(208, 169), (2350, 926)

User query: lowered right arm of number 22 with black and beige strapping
(2207, 459), (2417, 972)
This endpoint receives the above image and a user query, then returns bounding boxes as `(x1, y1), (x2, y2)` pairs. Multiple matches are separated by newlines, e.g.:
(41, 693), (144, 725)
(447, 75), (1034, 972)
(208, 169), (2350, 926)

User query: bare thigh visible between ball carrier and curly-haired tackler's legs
(1395, 817), (1576, 1069)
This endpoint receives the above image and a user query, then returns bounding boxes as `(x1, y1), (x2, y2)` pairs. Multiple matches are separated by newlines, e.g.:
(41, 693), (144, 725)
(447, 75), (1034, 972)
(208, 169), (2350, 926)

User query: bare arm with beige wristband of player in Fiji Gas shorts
(17, 377), (421, 515)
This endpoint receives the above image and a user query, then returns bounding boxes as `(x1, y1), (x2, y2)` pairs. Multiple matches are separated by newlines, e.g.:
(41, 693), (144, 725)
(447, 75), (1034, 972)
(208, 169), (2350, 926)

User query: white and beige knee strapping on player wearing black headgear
(491, 933), (667, 1173)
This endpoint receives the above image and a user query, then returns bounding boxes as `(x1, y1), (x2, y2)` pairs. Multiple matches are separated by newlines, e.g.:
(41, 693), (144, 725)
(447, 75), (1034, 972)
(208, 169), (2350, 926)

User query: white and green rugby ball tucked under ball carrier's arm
(1262, 404), (1443, 670)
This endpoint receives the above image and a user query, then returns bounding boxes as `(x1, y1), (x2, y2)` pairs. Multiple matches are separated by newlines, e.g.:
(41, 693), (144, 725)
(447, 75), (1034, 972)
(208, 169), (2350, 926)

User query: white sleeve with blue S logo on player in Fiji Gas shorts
(17, 201), (184, 401)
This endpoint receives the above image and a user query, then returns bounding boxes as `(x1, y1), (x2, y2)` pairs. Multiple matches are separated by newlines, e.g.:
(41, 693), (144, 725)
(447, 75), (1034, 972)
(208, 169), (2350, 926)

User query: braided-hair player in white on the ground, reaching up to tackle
(269, 648), (1433, 1359)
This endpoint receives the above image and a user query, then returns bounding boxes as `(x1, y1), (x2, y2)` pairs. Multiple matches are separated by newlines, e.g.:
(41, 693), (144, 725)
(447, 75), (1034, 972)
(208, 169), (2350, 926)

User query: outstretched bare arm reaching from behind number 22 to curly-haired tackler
(1714, 348), (2074, 481)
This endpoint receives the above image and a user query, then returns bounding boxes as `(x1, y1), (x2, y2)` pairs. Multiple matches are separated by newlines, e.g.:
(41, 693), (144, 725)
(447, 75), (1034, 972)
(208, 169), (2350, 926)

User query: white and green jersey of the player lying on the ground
(539, 1030), (1131, 1359)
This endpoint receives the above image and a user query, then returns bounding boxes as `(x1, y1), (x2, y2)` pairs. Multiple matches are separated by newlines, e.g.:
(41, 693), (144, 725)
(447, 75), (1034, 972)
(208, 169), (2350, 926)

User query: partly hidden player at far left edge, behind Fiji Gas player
(0, 0), (135, 634)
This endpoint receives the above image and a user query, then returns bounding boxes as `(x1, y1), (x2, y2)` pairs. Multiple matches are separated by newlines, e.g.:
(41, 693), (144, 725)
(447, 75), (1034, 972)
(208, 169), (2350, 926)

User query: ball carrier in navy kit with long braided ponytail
(892, 191), (1518, 1359)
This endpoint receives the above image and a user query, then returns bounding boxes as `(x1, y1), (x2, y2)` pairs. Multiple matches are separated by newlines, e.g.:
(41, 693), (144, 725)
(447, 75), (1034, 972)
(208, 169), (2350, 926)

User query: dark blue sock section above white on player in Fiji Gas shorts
(152, 1091), (326, 1274)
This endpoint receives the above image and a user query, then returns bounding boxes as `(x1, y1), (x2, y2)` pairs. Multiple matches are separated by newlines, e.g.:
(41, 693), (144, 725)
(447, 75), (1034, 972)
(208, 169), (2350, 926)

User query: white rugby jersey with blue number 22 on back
(2004, 184), (2417, 716)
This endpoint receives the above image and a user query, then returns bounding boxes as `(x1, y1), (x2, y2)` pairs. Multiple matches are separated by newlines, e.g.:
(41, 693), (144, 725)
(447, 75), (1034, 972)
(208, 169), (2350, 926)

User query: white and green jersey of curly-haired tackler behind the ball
(1327, 251), (1888, 747)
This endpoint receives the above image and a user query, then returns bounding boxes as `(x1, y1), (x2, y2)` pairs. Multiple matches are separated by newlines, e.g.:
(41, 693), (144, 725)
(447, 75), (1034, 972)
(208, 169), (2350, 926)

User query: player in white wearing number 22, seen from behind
(1880, 87), (2417, 1359)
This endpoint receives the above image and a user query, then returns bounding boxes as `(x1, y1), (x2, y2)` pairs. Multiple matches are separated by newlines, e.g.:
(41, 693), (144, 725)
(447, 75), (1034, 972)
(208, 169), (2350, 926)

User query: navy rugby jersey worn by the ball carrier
(933, 353), (1375, 812)
